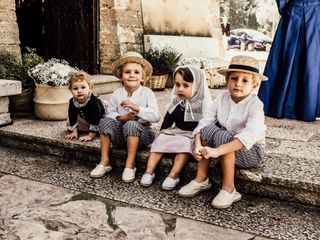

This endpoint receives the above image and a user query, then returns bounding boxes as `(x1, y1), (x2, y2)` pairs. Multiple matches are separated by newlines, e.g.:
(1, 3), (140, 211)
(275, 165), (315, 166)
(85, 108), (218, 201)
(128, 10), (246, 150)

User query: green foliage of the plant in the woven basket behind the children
(141, 47), (182, 75)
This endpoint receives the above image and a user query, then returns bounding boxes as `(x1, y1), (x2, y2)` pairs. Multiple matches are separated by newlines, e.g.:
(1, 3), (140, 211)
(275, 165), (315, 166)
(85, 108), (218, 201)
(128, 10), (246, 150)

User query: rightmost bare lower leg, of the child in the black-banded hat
(221, 152), (235, 192)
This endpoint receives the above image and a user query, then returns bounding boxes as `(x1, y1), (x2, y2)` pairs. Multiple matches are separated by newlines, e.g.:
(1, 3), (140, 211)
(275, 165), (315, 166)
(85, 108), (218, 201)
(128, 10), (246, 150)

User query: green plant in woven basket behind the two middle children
(141, 47), (182, 91)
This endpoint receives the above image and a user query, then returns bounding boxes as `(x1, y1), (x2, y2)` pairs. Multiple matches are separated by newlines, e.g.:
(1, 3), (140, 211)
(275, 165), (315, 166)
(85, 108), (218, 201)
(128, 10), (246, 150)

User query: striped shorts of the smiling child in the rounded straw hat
(99, 118), (155, 149)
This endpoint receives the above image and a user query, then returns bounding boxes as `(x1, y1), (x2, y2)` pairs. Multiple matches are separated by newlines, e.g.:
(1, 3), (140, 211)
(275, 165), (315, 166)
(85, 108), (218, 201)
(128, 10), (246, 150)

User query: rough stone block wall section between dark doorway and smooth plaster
(99, 0), (143, 73)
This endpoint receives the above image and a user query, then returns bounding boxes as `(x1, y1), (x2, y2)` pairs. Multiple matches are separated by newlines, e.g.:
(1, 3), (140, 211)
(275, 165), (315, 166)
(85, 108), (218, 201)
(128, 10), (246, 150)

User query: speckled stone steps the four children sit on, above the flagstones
(0, 80), (320, 240)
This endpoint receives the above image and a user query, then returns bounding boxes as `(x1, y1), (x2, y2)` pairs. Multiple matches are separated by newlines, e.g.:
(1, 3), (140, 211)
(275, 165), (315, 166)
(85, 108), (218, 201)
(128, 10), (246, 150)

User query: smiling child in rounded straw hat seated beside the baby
(90, 52), (160, 182)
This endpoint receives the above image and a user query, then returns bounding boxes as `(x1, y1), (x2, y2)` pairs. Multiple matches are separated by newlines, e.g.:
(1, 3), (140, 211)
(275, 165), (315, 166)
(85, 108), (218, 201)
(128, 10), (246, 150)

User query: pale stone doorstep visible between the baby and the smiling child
(91, 74), (122, 96)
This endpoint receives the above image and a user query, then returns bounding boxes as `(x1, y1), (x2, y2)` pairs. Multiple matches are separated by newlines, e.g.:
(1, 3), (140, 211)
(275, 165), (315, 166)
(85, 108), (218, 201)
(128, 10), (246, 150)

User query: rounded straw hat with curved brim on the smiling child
(112, 52), (152, 79)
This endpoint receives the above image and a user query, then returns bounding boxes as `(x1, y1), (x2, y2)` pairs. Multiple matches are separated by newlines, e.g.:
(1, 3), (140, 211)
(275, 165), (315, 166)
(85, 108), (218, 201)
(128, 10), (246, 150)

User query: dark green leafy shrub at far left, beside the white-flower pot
(0, 48), (43, 89)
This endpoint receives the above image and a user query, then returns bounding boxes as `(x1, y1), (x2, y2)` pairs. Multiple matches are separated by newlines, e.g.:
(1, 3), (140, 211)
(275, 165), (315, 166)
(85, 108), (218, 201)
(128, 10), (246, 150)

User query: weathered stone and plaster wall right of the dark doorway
(99, 0), (223, 73)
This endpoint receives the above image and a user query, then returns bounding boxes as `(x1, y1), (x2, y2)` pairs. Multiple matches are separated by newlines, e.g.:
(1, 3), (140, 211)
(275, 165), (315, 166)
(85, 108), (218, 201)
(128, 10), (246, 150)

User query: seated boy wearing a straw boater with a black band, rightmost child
(179, 56), (267, 208)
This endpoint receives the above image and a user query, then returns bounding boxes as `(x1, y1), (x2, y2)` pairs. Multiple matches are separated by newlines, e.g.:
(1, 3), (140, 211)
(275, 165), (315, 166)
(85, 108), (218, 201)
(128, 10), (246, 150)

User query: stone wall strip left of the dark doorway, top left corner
(0, 0), (21, 54)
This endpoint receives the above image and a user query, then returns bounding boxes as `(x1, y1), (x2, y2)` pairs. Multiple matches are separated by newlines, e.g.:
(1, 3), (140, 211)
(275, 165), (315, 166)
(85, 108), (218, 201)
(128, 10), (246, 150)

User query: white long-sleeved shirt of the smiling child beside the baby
(107, 86), (161, 123)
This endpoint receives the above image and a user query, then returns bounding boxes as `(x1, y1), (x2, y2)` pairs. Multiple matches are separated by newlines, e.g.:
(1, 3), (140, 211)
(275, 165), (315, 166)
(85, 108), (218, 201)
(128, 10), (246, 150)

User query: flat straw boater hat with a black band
(218, 55), (268, 81)
